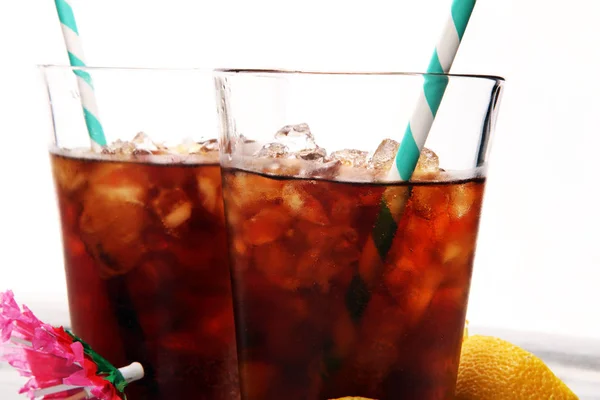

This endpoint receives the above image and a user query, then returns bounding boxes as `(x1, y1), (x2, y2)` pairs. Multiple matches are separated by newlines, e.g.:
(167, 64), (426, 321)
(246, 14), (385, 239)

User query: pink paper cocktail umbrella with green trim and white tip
(0, 291), (144, 400)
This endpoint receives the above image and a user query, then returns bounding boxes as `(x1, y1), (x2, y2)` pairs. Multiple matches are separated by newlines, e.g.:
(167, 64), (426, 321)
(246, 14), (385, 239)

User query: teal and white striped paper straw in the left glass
(54, 0), (106, 150)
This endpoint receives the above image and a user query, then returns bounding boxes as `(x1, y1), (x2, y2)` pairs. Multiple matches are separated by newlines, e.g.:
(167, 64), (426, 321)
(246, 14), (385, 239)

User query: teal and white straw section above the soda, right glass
(389, 0), (476, 181)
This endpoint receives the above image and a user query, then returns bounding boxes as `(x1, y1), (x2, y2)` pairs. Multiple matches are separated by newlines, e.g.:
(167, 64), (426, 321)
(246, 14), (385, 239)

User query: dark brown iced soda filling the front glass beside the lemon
(222, 169), (485, 400)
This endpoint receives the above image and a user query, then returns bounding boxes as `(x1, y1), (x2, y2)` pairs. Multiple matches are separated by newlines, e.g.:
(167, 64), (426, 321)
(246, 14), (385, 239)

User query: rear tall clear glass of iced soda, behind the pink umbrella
(43, 66), (239, 400)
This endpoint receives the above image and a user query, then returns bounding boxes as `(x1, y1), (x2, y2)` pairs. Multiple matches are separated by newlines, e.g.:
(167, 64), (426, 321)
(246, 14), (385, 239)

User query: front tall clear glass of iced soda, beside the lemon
(216, 70), (503, 400)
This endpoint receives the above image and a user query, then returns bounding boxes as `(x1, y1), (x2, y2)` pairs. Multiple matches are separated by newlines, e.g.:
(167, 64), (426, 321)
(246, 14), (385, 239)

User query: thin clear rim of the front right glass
(213, 68), (506, 83)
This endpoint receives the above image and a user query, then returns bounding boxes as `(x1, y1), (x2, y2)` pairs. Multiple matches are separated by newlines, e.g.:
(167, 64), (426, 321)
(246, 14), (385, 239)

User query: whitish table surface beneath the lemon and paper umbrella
(0, 327), (600, 400)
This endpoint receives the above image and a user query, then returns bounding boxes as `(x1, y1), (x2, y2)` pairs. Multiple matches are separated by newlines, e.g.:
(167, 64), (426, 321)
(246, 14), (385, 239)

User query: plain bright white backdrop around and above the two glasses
(0, 0), (600, 338)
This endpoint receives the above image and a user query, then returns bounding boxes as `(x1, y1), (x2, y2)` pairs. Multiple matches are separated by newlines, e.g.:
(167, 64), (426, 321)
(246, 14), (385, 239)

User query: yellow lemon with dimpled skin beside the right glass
(456, 335), (577, 400)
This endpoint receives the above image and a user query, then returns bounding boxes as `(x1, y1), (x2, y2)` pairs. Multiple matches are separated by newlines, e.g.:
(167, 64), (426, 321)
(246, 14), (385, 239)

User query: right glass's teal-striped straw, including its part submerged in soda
(359, 0), (476, 287)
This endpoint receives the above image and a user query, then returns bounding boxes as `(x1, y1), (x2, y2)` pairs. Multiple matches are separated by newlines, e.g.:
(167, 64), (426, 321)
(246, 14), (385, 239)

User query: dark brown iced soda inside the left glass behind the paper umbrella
(51, 154), (239, 400)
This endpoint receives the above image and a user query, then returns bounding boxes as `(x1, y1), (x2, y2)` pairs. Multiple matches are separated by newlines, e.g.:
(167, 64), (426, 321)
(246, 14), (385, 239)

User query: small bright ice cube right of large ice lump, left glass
(152, 188), (192, 230)
